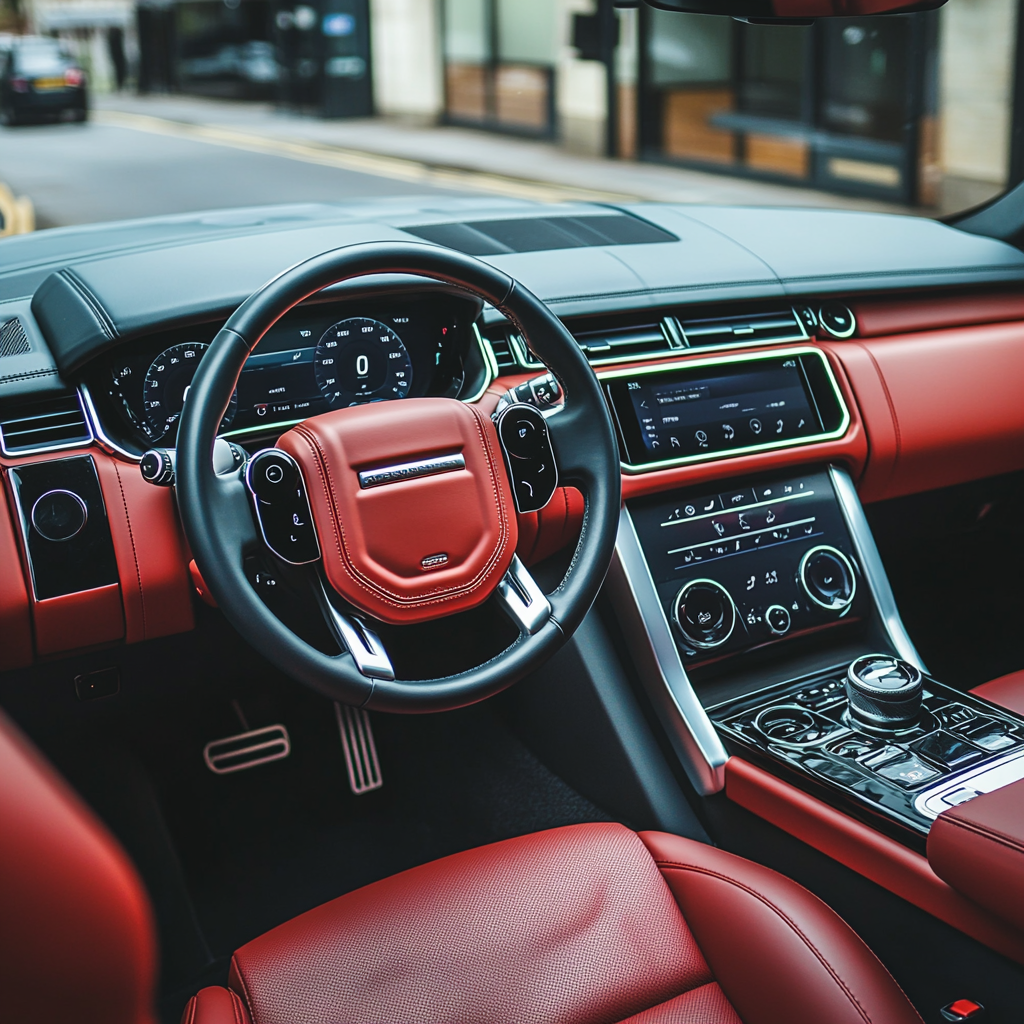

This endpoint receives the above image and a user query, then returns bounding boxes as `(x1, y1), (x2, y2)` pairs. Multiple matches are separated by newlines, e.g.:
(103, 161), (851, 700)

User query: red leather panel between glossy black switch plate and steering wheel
(93, 455), (195, 643)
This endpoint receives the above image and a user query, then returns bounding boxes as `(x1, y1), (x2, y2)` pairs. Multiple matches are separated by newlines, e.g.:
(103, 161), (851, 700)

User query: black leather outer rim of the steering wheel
(175, 242), (621, 713)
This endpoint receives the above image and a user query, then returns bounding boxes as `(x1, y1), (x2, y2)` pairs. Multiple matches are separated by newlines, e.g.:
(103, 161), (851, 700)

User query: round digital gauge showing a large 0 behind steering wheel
(313, 316), (413, 409)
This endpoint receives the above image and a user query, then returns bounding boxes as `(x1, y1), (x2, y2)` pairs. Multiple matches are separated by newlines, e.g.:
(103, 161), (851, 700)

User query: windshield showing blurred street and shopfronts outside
(0, 0), (1011, 227)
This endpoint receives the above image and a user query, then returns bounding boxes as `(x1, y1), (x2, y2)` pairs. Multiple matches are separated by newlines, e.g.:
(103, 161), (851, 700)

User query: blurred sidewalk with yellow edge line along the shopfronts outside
(94, 94), (914, 213)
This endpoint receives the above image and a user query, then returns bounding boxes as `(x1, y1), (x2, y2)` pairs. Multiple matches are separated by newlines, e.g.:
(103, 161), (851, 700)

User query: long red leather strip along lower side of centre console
(725, 758), (1024, 964)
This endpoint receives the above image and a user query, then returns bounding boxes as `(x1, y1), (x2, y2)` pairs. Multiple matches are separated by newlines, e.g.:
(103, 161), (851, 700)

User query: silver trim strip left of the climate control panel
(608, 508), (728, 796)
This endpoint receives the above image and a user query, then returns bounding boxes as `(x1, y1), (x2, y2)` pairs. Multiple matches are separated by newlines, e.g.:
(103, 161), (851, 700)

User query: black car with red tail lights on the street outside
(0, 36), (89, 125)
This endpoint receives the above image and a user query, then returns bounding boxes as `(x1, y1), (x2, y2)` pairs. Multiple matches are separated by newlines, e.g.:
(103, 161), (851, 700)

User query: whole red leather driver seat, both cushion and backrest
(0, 715), (921, 1024)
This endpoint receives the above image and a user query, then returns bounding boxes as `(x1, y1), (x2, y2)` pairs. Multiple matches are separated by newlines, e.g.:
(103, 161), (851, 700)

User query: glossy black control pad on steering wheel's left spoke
(246, 449), (321, 565)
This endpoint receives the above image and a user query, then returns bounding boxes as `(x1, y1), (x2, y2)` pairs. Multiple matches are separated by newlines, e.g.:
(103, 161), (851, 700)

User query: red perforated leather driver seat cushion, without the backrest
(182, 823), (921, 1024)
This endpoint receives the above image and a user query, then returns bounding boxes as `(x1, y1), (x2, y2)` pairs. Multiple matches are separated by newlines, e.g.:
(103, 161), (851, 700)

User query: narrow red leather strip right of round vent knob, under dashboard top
(850, 291), (1024, 338)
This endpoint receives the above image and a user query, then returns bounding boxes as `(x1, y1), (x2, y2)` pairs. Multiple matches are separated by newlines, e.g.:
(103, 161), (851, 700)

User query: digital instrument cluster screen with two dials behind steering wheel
(86, 295), (484, 449)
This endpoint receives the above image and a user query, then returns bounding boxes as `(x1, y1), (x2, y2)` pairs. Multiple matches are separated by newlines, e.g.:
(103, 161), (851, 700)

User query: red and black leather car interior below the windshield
(6, 0), (1024, 1024)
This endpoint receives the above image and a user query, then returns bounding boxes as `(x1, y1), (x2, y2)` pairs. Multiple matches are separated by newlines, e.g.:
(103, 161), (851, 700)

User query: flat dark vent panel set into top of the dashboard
(402, 213), (679, 256)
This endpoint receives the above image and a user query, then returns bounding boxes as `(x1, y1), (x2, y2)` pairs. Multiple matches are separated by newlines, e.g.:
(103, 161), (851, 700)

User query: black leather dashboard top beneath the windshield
(0, 197), (1024, 387)
